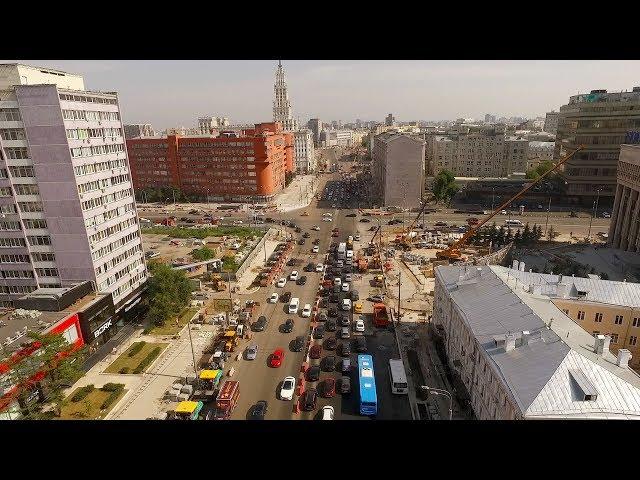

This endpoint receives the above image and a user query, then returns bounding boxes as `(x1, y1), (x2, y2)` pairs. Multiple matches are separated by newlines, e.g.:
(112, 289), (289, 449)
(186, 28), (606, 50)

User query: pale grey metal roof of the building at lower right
(436, 266), (640, 419)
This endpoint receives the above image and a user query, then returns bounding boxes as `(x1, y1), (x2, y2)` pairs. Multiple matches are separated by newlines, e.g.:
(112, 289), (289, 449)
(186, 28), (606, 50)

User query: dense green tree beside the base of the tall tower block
(147, 262), (193, 326)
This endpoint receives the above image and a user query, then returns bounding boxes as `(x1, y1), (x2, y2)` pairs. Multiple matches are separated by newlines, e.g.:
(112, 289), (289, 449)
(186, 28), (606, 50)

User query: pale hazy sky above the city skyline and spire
(14, 60), (640, 130)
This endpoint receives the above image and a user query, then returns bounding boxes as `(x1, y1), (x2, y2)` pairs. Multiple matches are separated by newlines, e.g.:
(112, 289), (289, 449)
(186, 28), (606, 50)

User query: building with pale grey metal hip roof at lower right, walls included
(432, 263), (640, 420)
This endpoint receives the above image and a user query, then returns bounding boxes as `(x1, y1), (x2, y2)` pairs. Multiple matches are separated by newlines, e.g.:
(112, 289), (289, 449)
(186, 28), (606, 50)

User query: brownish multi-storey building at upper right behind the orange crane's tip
(554, 87), (640, 205)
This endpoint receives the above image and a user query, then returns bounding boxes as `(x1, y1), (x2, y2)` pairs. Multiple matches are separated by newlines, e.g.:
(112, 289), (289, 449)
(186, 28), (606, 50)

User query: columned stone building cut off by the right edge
(609, 145), (640, 252)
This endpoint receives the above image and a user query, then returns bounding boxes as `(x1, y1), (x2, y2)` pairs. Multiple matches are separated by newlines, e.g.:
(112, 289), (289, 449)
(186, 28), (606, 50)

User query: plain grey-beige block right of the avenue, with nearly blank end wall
(371, 132), (425, 208)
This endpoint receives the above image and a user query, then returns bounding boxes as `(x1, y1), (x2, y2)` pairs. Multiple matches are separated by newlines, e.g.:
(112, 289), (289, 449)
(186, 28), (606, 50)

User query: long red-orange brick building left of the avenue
(127, 123), (295, 202)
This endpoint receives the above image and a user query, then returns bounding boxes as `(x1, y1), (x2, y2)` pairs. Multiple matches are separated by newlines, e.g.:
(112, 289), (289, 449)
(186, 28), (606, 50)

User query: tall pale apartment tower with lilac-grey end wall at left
(0, 64), (147, 309)
